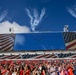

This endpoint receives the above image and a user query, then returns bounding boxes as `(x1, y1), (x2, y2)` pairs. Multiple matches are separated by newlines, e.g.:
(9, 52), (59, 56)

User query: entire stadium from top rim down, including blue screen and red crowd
(0, 32), (76, 75)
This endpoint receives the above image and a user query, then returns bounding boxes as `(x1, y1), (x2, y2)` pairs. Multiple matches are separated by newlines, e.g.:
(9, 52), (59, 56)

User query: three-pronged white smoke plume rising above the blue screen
(25, 8), (46, 31)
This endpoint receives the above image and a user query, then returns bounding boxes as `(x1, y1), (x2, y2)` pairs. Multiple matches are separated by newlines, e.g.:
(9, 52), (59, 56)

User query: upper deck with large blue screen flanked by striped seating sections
(0, 32), (76, 52)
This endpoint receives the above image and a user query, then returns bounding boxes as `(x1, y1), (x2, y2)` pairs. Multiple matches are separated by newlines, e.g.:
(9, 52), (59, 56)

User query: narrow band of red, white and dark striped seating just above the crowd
(0, 53), (76, 59)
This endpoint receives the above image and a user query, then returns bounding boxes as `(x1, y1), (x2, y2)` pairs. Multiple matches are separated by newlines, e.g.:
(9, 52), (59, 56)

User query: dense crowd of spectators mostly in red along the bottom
(0, 60), (76, 75)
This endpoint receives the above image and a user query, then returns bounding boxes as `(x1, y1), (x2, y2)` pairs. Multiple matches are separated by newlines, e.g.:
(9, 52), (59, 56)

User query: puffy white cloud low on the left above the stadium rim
(0, 21), (30, 34)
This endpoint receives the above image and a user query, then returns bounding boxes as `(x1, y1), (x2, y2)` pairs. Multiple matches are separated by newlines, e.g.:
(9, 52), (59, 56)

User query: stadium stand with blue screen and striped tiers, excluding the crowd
(0, 32), (76, 60)
